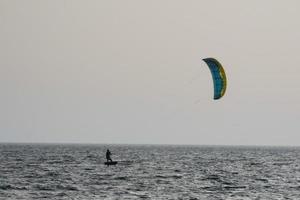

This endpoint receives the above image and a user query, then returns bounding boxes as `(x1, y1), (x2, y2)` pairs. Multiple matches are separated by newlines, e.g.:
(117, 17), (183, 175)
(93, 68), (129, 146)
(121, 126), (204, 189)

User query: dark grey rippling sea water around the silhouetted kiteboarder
(0, 144), (300, 200)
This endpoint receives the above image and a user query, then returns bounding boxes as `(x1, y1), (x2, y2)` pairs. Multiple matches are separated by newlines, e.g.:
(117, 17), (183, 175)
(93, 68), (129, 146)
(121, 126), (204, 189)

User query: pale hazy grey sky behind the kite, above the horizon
(0, 0), (300, 146)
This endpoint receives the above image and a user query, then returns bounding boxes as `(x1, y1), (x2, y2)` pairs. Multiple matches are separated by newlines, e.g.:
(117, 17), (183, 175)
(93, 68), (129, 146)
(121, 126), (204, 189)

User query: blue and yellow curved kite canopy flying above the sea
(203, 58), (227, 100)
